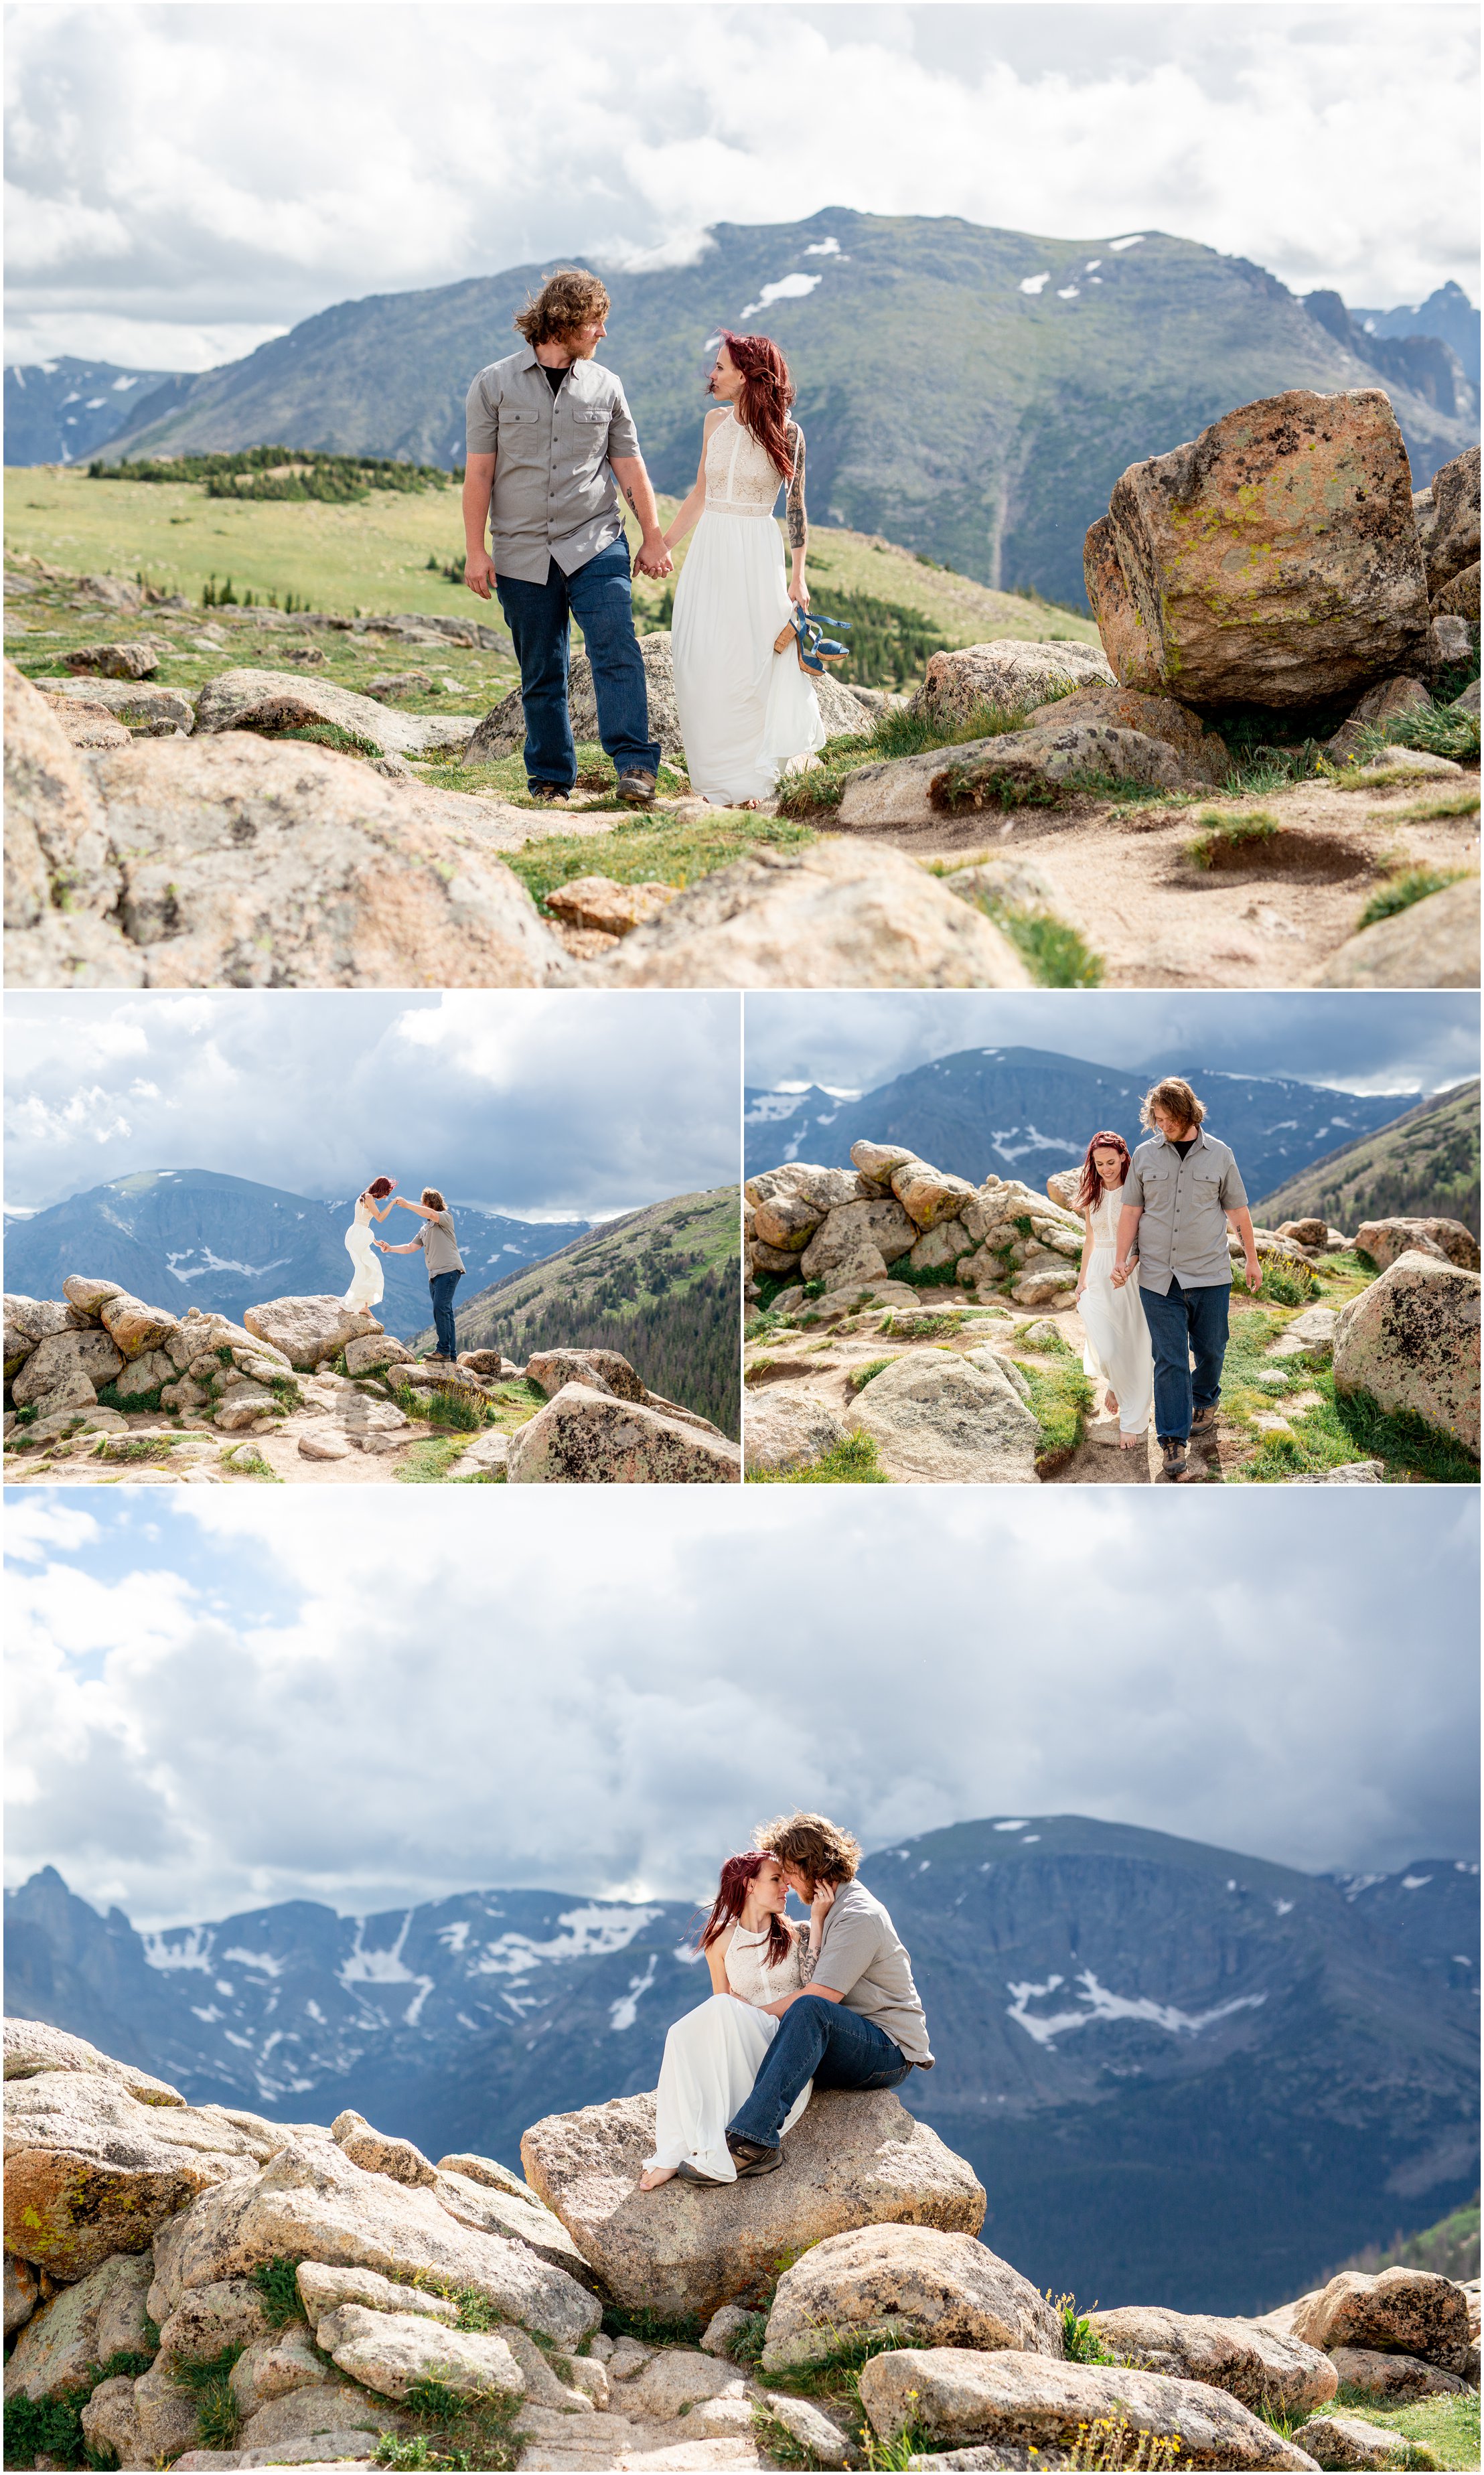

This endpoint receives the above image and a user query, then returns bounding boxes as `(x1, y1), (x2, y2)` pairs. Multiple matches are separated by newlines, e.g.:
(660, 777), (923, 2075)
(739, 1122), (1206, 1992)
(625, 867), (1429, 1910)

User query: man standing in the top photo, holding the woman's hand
(463, 267), (673, 807)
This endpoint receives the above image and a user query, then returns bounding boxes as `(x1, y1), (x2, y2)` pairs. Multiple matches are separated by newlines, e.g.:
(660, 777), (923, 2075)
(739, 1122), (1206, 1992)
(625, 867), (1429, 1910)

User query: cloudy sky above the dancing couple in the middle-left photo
(5, 990), (739, 1220)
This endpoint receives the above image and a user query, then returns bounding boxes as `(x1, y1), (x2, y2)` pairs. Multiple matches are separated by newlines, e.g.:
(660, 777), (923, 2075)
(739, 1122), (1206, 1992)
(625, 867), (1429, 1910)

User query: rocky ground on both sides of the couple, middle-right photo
(742, 1141), (1479, 1485)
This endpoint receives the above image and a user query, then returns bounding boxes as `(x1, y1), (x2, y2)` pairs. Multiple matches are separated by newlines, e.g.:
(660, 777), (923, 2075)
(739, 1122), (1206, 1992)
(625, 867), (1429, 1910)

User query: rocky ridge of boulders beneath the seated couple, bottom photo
(5, 2020), (1479, 2475)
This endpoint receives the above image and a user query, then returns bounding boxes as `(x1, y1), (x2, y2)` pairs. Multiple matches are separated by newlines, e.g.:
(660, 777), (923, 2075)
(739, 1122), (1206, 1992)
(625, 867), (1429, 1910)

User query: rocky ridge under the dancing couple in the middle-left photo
(5, 1274), (739, 1485)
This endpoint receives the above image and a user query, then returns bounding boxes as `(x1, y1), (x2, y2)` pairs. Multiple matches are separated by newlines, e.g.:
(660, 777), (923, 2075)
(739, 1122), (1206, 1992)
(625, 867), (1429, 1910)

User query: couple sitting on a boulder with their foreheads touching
(641, 1814), (932, 2190)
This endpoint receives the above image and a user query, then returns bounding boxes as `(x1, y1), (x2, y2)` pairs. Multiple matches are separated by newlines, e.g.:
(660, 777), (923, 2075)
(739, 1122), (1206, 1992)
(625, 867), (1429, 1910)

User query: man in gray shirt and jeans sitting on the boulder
(678, 1814), (932, 2183)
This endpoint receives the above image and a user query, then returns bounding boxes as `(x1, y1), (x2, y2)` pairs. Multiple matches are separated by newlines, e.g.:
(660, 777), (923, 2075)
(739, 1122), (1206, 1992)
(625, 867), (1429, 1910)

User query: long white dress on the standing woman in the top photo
(670, 411), (828, 807)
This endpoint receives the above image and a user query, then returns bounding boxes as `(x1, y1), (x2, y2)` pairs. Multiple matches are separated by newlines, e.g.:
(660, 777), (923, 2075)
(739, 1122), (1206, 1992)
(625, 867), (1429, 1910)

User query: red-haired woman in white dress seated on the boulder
(638, 1852), (834, 2190)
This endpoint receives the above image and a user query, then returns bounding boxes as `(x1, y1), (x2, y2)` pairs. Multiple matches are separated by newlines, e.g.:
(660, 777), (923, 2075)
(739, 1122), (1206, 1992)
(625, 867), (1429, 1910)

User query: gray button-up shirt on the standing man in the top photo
(465, 344), (638, 584)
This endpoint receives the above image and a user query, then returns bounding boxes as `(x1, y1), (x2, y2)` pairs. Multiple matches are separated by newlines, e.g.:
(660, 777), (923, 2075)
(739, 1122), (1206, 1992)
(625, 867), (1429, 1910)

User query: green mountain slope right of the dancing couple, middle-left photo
(421, 1185), (742, 1436)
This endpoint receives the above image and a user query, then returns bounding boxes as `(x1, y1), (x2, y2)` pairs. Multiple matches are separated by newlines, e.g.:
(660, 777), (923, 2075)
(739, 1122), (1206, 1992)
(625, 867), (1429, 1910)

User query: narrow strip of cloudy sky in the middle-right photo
(745, 990), (1479, 1092)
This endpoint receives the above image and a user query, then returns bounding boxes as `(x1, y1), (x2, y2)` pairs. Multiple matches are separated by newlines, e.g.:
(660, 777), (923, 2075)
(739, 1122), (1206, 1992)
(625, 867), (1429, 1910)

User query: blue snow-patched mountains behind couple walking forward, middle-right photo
(742, 1049), (1422, 1203)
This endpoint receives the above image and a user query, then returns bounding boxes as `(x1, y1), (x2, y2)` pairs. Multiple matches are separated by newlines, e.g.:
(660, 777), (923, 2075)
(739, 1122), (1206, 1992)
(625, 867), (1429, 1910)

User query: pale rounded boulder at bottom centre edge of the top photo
(593, 836), (1034, 988)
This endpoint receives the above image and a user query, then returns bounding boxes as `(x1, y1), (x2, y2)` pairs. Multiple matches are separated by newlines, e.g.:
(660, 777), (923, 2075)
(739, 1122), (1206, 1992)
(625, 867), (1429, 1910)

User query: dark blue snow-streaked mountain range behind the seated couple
(5, 1814), (1479, 2312)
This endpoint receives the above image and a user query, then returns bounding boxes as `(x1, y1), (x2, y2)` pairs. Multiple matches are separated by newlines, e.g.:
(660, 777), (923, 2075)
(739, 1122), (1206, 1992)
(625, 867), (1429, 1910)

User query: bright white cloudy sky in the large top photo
(5, 0), (1477, 369)
